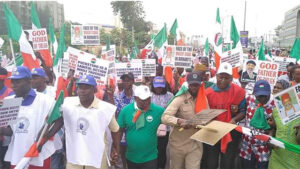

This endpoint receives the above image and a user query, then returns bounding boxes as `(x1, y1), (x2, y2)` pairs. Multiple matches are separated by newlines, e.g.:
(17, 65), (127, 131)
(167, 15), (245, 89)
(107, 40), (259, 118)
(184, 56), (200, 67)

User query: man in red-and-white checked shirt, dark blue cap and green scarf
(240, 80), (275, 169)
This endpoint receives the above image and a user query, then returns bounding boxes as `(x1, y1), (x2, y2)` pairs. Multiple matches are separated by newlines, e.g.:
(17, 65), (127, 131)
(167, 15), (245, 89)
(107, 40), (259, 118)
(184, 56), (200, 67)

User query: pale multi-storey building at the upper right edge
(275, 5), (300, 48)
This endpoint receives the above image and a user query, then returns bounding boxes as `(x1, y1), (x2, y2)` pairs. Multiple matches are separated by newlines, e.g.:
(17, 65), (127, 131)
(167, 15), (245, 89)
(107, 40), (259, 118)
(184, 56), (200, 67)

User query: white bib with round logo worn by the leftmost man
(5, 92), (61, 166)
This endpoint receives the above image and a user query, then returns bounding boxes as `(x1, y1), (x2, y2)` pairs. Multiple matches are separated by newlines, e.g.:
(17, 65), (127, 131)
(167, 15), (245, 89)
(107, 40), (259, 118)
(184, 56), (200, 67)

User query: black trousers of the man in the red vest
(201, 130), (241, 169)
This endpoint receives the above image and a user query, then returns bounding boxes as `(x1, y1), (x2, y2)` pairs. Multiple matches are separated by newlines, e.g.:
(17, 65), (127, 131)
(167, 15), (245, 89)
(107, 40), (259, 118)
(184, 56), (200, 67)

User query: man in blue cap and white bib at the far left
(0, 66), (61, 169)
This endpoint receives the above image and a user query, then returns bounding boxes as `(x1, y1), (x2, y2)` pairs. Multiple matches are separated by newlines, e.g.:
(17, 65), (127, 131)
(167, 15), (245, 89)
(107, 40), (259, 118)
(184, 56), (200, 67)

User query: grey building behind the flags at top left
(0, 1), (65, 35)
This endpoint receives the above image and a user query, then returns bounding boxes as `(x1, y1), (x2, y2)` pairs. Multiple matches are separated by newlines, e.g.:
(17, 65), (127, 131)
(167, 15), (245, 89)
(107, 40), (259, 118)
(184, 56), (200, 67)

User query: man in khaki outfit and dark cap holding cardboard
(162, 72), (203, 169)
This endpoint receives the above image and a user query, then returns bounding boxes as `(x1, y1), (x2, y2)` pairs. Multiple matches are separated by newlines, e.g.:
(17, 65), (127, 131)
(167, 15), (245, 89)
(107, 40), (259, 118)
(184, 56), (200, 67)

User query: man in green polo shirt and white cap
(118, 85), (164, 169)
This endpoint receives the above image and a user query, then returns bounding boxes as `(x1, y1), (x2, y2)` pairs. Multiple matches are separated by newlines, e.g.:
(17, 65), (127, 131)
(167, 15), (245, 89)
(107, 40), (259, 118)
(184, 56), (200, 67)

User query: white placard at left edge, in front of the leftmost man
(0, 97), (23, 127)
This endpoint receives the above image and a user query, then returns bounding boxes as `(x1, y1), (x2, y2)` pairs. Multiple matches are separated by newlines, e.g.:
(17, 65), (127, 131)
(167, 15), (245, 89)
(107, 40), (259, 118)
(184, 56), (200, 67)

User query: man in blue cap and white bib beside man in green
(44, 75), (120, 169)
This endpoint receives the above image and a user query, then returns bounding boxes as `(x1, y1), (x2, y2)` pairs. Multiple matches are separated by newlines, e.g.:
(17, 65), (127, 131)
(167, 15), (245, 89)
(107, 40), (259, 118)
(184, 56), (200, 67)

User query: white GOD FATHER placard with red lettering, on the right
(256, 61), (279, 88)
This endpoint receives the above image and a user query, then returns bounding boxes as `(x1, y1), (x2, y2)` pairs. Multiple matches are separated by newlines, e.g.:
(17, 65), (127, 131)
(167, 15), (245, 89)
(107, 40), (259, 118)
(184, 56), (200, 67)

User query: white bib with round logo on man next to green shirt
(62, 97), (116, 168)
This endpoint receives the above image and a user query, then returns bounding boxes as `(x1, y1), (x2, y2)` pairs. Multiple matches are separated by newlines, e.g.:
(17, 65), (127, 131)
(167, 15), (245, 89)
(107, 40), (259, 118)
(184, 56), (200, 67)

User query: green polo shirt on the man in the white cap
(118, 103), (164, 163)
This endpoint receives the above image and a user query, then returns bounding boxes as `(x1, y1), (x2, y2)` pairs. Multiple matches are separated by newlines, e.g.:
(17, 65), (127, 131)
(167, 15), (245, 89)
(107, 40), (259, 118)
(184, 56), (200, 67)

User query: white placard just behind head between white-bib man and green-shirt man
(115, 62), (143, 83)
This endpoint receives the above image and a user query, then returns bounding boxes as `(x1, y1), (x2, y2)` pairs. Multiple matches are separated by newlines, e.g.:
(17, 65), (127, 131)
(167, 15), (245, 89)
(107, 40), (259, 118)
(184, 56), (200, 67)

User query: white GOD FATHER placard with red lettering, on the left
(25, 28), (48, 51)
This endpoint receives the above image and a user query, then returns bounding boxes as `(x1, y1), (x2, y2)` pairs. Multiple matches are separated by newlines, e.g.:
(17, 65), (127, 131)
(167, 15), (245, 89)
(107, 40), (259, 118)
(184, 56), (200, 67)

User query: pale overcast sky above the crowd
(58, 0), (300, 43)
